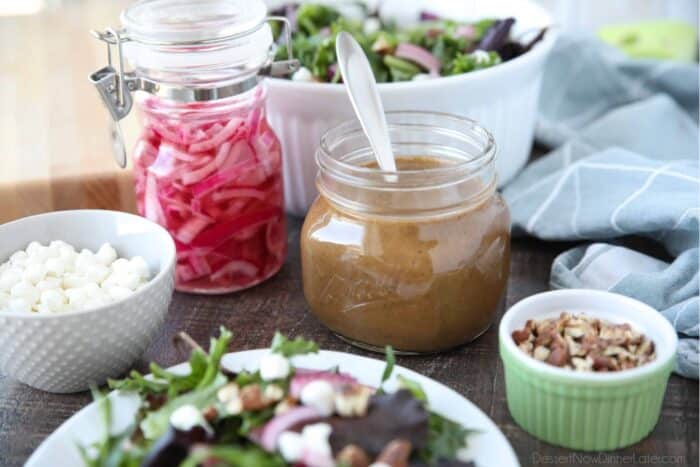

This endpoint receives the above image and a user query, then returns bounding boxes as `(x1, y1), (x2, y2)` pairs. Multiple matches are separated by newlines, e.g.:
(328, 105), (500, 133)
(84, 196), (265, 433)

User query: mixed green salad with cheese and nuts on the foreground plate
(79, 328), (474, 467)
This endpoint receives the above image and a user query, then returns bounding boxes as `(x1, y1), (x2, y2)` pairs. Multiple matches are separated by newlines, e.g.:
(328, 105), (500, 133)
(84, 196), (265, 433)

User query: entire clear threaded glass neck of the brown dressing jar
(316, 111), (496, 219)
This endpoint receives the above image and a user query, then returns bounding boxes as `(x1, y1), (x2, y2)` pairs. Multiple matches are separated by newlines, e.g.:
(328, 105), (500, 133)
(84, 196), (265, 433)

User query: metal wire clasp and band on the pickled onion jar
(89, 16), (299, 168)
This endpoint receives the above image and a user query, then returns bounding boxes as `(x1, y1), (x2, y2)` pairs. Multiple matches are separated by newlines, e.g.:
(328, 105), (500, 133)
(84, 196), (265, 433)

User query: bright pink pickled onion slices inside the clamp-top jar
(134, 93), (287, 290)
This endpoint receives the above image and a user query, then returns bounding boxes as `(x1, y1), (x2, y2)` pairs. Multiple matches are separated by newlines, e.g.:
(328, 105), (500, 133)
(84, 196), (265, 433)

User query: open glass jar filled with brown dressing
(301, 112), (510, 353)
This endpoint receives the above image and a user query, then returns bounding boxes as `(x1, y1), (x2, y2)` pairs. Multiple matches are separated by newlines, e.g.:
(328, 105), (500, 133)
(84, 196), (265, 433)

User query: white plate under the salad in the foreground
(25, 349), (520, 467)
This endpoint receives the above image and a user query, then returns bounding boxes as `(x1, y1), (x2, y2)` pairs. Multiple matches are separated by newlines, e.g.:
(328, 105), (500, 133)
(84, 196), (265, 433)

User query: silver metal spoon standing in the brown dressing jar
(335, 32), (396, 174)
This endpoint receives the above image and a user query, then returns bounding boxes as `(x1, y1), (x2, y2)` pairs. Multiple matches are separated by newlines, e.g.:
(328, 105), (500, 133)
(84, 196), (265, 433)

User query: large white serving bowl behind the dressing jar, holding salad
(267, 0), (555, 215)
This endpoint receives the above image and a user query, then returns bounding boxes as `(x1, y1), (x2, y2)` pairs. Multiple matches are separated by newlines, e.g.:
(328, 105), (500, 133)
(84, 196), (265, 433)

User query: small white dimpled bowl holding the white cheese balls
(0, 210), (175, 393)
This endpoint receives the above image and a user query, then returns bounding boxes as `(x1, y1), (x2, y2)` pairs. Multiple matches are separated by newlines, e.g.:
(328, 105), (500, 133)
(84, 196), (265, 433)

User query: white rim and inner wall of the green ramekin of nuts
(498, 289), (678, 382)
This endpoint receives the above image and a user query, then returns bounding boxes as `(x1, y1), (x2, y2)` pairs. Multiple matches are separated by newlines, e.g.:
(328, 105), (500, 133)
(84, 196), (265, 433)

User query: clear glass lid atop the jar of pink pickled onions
(121, 0), (273, 79)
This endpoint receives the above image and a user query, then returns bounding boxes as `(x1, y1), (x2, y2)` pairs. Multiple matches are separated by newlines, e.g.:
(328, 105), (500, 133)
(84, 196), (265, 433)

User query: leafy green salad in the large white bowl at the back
(272, 3), (546, 83)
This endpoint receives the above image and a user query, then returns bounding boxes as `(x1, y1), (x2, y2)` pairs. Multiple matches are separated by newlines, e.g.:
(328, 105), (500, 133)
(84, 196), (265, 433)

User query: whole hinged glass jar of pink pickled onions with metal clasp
(90, 0), (298, 293)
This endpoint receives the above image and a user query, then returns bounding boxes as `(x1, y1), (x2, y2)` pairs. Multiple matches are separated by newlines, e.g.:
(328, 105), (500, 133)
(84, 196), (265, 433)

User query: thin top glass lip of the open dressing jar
(316, 110), (496, 183)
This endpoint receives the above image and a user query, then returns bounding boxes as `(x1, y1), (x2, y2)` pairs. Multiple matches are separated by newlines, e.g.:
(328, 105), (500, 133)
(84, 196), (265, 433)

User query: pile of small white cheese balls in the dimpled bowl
(0, 240), (150, 313)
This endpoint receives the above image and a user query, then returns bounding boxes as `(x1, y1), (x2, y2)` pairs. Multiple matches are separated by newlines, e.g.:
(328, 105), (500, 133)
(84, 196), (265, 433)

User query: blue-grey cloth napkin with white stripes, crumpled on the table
(504, 36), (700, 378)
